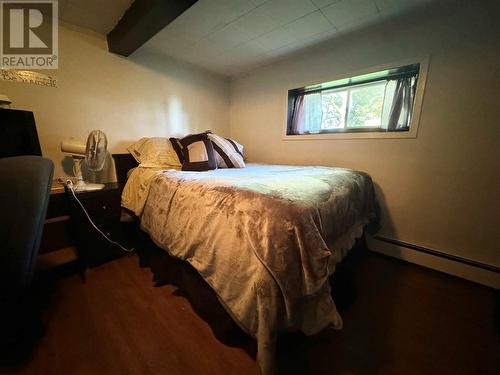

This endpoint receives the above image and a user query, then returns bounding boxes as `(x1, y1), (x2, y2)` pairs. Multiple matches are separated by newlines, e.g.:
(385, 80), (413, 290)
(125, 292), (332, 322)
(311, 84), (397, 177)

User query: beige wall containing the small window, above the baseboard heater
(231, 1), (500, 266)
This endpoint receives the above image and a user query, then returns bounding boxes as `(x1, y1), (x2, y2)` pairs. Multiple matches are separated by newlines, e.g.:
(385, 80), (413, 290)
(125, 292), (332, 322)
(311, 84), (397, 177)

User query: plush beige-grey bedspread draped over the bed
(117, 159), (375, 374)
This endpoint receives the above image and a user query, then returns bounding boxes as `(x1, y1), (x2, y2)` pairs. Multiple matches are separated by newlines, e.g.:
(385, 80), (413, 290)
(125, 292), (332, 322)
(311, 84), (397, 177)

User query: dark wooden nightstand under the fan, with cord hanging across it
(66, 182), (126, 279)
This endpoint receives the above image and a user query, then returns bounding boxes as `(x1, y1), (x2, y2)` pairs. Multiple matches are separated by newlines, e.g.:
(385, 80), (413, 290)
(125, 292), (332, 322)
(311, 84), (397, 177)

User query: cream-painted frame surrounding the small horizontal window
(282, 56), (429, 141)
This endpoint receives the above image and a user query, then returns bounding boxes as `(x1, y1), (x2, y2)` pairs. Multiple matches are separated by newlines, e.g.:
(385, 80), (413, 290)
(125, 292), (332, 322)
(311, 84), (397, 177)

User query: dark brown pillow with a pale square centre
(179, 133), (217, 171)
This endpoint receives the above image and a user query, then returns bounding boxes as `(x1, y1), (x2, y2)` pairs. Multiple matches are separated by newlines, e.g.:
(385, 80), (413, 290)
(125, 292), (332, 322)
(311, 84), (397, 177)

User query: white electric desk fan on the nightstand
(61, 130), (108, 191)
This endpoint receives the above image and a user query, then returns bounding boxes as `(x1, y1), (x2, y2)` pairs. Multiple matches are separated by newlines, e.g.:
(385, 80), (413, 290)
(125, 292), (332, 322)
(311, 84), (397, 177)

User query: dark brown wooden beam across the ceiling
(107, 0), (198, 56)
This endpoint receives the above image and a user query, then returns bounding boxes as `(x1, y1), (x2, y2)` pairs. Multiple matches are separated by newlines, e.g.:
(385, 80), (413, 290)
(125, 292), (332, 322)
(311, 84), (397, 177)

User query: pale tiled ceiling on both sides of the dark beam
(59, 0), (433, 76)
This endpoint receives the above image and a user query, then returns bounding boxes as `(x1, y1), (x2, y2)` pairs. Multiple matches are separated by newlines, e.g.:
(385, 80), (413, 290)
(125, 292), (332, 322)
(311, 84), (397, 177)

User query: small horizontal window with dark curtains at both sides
(286, 64), (420, 136)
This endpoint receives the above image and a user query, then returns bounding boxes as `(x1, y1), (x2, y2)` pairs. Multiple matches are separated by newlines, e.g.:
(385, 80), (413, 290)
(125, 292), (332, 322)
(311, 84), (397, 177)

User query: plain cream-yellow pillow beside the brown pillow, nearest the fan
(127, 138), (181, 168)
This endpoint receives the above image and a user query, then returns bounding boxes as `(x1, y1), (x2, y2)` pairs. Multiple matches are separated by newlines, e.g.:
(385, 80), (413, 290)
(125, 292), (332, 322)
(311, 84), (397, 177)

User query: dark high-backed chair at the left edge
(0, 156), (54, 364)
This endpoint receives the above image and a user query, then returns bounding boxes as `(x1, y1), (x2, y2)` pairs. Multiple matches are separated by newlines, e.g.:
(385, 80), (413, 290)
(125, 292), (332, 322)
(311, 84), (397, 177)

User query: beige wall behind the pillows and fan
(0, 26), (229, 176)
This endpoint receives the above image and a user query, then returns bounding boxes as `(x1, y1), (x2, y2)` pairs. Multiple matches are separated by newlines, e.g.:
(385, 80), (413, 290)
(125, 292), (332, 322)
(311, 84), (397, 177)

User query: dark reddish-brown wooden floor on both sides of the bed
(0, 253), (500, 375)
